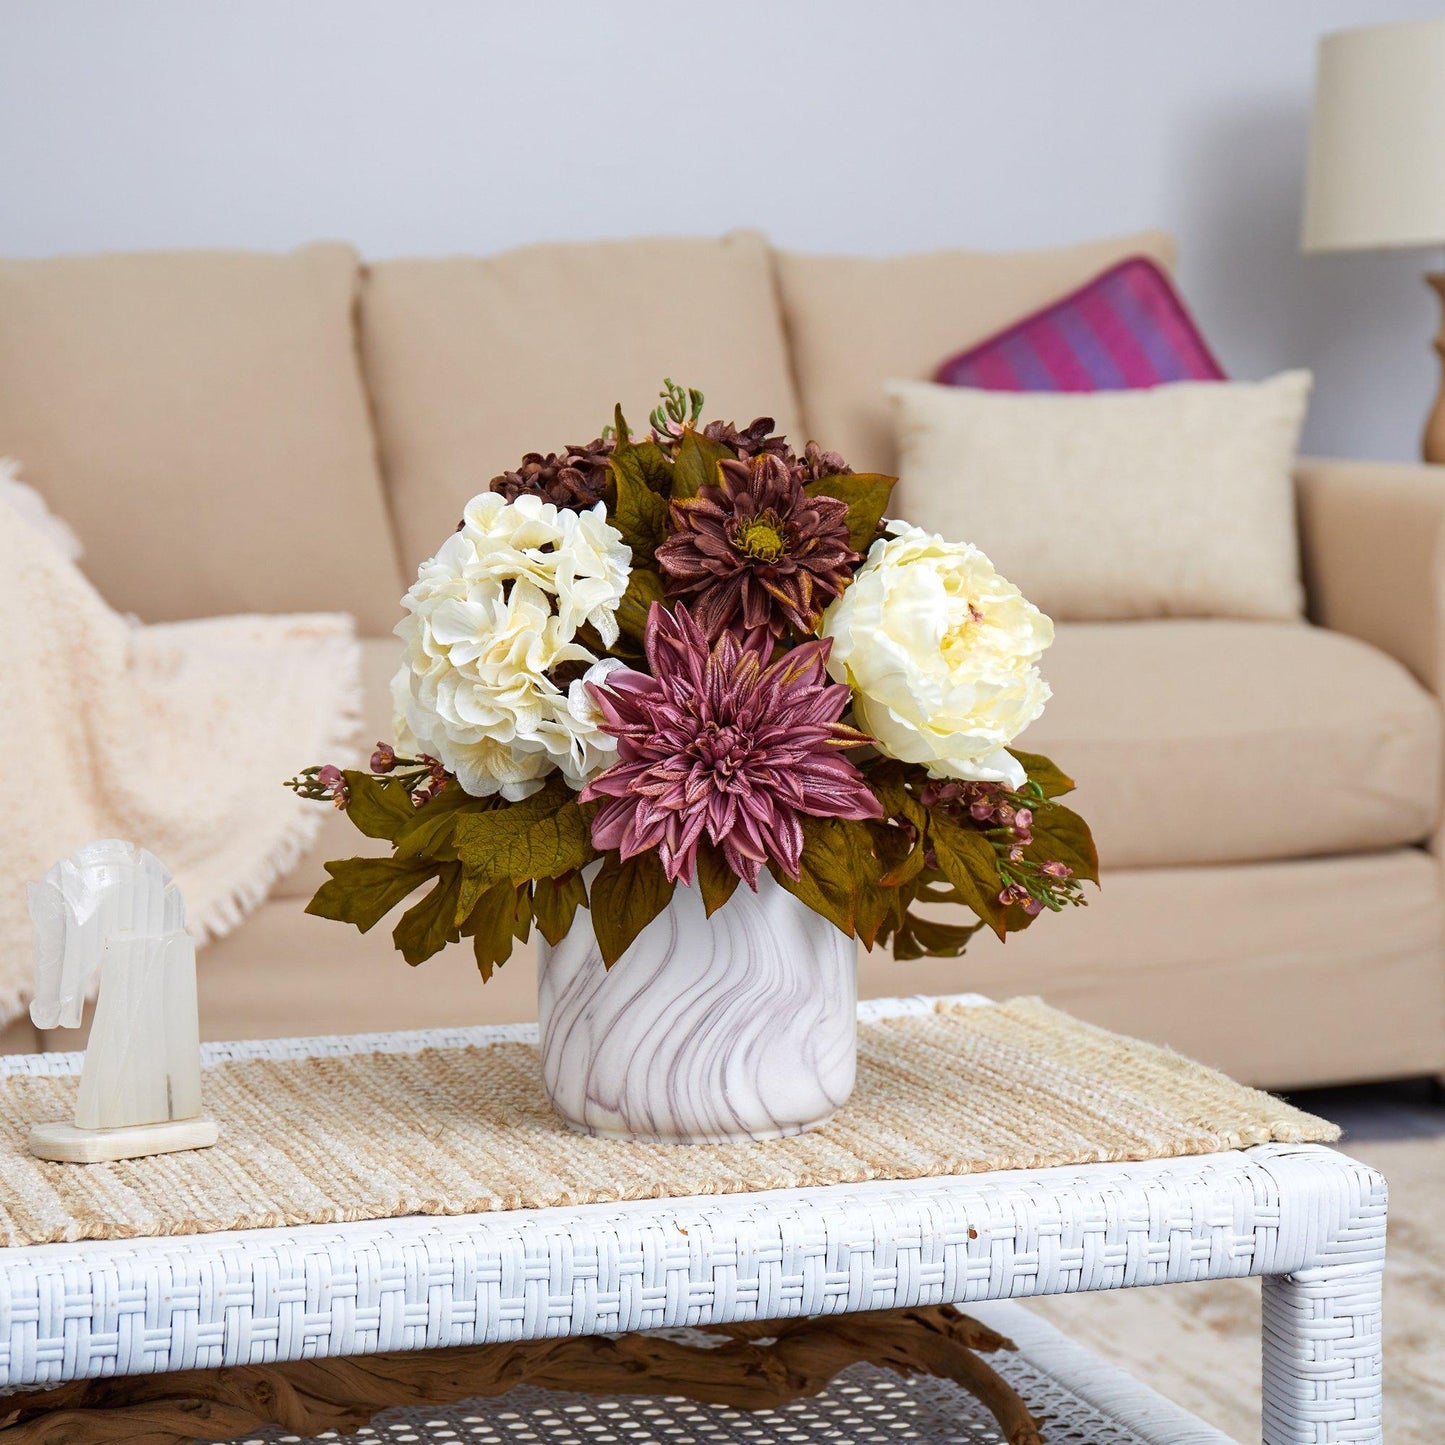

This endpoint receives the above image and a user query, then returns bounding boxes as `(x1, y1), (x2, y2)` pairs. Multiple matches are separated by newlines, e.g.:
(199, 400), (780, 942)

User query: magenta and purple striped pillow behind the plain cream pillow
(933, 256), (1225, 392)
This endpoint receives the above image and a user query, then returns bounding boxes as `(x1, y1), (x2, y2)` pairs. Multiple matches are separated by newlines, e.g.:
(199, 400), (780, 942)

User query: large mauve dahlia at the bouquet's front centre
(581, 603), (883, 890)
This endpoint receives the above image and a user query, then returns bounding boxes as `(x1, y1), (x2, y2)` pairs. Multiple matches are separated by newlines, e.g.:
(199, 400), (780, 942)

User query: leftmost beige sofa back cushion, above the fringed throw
(0, 246), (400, 631)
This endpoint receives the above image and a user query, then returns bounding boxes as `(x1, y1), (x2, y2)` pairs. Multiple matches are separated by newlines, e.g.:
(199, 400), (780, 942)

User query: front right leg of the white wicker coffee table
(1264, 1260), (1384, 1445)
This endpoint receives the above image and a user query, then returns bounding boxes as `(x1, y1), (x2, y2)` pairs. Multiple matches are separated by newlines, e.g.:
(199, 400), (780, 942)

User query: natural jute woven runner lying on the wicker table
(0, 998), (1338, 1244)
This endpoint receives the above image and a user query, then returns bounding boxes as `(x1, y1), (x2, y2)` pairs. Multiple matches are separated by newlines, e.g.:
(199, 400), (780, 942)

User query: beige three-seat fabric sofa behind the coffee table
(0, 233), (1445, 1085)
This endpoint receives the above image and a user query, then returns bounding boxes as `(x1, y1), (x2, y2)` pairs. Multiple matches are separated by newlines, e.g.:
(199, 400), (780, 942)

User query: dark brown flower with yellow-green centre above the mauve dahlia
(657, 452), (860, 637)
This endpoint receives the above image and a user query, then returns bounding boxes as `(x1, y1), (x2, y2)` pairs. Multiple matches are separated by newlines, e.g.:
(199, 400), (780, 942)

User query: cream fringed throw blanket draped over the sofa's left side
(0, 478), (360, 1026)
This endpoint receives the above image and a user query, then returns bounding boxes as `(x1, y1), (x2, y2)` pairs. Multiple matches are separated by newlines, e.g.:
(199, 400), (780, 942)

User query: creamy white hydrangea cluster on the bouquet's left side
(392, 493), (631, 799)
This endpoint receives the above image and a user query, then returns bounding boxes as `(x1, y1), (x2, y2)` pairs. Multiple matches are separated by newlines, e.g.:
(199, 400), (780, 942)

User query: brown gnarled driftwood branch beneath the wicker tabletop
(0, 1305), (1043, 1445)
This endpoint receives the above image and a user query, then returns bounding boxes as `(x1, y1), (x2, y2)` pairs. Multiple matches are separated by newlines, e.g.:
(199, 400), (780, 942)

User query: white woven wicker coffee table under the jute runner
(0, 1000), (1386, 1445)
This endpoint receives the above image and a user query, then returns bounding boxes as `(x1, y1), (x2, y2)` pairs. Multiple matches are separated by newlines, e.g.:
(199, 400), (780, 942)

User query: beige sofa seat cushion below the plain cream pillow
(1019, 621), (1441, 870)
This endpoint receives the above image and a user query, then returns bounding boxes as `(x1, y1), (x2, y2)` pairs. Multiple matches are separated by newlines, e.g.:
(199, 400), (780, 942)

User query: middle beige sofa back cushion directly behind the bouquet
(361, 233), (809, 569)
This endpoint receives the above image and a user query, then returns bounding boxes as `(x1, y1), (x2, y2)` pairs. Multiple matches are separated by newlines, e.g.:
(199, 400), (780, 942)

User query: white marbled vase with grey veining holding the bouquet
(538, 870), (858, 1144)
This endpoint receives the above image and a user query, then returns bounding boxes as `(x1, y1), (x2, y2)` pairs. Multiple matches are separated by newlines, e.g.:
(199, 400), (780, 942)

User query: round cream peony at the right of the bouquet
(822, 522), (1053, 788)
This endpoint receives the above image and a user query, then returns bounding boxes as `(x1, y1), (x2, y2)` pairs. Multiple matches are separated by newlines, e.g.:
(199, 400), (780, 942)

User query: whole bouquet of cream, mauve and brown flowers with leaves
(288, 380), (1098, 978)
